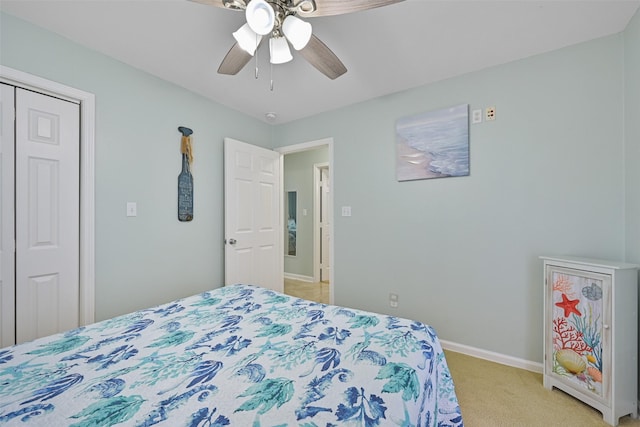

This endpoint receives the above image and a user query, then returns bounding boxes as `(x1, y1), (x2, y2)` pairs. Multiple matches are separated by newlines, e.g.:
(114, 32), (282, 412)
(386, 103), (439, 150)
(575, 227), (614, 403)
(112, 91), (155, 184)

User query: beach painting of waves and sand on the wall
(396, 104), (469, 181)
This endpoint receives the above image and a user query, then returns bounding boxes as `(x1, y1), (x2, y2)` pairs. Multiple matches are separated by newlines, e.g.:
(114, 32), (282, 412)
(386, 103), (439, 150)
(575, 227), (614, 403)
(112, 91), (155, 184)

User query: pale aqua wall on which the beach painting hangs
(274, 35), (625, 362)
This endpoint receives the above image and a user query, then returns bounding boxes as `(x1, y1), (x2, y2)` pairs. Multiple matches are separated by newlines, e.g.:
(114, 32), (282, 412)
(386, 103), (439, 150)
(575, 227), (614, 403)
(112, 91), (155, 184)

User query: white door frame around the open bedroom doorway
(274, 138), (335, 304)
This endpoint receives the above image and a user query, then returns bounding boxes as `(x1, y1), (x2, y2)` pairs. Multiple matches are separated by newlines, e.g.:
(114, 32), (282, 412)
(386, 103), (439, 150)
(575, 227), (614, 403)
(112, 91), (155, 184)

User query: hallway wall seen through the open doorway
(284, 147), (329, 277)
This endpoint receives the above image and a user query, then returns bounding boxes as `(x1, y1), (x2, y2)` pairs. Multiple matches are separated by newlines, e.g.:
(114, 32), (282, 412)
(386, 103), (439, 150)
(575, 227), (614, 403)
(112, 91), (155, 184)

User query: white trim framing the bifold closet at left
(0, 65), (96, 325)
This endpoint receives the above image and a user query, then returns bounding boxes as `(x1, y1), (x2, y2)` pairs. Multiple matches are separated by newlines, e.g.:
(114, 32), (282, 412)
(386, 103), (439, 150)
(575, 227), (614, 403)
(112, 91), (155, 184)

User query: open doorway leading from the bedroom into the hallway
(276, 138), (333, 304)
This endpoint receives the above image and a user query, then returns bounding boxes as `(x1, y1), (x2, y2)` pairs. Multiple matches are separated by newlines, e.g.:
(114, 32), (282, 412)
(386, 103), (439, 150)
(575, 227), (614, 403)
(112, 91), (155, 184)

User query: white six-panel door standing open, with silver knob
(224, 138), (284, 292)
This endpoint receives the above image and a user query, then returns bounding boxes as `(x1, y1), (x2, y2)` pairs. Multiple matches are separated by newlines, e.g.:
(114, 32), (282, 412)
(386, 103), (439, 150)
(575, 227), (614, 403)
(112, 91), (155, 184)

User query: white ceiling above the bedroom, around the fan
(0, 0), (640, 123)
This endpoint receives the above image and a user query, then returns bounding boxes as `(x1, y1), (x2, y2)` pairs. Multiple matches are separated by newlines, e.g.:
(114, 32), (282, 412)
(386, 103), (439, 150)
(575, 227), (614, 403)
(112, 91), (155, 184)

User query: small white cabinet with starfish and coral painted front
(541, 257), (638, 425)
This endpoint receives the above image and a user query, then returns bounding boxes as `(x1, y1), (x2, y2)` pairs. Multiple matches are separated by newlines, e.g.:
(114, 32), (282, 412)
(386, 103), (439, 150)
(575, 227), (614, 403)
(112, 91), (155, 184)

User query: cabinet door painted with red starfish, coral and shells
(545, 266), (611, 403)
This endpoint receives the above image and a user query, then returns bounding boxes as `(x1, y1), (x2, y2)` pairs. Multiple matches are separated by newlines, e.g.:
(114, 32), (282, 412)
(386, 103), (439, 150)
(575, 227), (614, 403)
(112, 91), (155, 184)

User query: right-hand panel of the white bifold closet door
(2, 84), (80, 343)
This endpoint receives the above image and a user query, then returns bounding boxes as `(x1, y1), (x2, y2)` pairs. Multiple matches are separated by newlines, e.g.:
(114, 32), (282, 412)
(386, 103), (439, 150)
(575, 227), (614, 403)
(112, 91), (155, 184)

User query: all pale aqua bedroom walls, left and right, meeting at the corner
(0, 8), (640, 368)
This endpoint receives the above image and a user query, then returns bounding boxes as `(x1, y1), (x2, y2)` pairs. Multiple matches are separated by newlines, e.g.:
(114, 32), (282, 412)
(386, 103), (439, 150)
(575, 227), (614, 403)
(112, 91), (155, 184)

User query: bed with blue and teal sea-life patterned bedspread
(0, 285), (463, 427)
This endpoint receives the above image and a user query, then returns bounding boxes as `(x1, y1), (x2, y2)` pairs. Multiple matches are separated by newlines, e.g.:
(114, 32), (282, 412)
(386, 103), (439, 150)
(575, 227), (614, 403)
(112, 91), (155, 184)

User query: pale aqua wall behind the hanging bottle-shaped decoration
(0, 14), (270, 319)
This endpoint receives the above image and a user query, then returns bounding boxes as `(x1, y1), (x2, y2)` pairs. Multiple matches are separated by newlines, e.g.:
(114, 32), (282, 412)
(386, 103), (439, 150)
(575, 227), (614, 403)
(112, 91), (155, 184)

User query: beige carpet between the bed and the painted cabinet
(445, 351), (640, 427)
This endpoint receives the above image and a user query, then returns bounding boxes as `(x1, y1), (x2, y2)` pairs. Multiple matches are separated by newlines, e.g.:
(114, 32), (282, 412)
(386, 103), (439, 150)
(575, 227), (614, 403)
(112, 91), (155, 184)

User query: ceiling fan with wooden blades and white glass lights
(192, 0), (404, 79)
